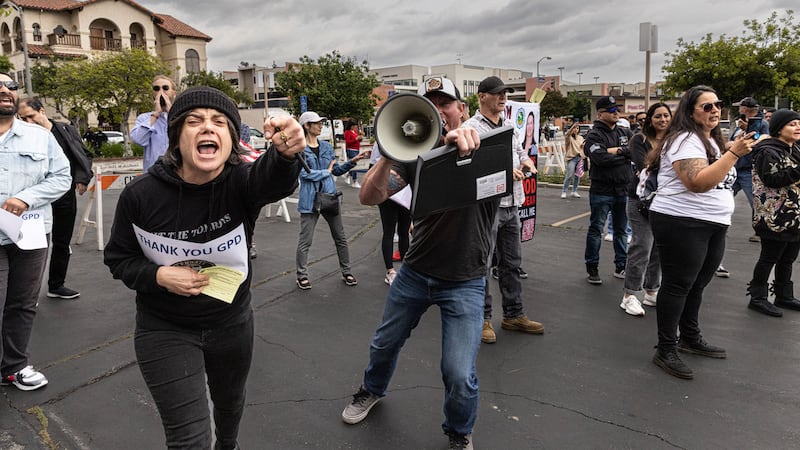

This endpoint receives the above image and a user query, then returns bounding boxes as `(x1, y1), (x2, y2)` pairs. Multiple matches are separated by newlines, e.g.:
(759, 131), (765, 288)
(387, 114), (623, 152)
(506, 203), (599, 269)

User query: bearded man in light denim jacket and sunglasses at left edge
(0, 73), (72, 391)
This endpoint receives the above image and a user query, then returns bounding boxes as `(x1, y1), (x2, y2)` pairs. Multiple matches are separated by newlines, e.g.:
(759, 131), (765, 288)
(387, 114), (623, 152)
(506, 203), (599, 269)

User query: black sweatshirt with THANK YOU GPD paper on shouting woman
(104, 150), (300, 329)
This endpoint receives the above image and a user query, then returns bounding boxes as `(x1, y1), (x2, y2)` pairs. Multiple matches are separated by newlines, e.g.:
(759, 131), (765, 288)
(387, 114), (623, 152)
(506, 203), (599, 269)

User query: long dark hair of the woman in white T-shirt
(646, 85), (725, 170)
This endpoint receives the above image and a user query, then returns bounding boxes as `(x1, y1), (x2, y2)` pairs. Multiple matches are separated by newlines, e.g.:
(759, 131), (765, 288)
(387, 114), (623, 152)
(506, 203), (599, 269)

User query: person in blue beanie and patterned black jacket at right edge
(747, 109), (800, 317)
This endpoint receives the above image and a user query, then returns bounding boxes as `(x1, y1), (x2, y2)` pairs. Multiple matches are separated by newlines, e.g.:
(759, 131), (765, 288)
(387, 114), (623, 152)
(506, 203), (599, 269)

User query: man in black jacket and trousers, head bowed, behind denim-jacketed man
(19, 97), (92, 299)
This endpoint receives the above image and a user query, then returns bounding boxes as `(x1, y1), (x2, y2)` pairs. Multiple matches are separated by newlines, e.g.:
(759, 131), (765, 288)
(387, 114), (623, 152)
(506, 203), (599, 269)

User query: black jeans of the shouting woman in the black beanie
(134, 312), (253, 449)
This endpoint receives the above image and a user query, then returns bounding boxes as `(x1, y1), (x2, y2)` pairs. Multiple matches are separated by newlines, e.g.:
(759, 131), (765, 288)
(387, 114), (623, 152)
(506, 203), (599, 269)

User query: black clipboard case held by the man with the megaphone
(411, 125), (514, 218)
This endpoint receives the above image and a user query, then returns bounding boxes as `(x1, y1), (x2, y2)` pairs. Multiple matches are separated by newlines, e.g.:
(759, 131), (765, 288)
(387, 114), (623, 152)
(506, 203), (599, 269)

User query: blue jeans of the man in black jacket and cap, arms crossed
(584, 192), (628, 270)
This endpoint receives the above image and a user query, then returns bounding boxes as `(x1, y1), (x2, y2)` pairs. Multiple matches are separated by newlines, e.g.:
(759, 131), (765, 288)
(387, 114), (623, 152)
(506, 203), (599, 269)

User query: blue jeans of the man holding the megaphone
(364, 265), (486, 434)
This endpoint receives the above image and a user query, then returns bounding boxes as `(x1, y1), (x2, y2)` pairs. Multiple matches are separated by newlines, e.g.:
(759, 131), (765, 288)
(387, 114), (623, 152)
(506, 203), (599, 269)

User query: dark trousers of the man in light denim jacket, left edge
(0, 244), (47, 376)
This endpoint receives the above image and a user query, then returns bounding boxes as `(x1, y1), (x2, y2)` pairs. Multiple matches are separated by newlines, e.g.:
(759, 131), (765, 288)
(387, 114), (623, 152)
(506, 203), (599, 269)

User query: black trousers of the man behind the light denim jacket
(47, 188), (78, 291)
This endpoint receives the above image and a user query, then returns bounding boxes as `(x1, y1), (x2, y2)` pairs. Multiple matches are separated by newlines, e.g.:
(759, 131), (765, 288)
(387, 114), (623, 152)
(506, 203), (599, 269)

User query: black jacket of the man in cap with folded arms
(583, 120), (633, 195)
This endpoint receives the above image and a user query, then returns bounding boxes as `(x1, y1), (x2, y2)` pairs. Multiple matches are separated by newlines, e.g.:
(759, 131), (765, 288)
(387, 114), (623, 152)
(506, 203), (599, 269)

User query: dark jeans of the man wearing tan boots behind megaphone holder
(483, 206), (524, 320)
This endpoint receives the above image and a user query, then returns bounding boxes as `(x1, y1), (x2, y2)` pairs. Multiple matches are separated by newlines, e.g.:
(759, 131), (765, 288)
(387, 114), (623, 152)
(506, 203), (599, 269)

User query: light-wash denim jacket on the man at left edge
(0, 119), (72, 245)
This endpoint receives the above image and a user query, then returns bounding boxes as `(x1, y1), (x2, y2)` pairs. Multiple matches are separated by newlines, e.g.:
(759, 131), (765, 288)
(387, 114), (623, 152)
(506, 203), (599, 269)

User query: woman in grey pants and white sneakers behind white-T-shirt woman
(619, 102), (672, 316)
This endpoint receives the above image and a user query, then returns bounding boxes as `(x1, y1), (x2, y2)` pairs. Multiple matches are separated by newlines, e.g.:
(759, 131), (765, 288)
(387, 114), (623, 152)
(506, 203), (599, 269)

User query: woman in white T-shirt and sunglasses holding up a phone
(648, 86), (753, 379)
